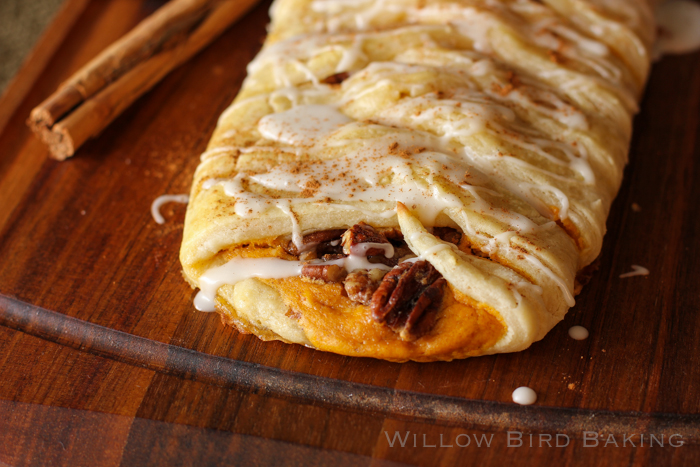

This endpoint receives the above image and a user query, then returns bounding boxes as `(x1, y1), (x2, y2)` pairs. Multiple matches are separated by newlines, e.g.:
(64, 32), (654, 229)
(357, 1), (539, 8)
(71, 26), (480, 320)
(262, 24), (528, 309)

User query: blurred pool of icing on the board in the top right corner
(654, 0), (700, 57)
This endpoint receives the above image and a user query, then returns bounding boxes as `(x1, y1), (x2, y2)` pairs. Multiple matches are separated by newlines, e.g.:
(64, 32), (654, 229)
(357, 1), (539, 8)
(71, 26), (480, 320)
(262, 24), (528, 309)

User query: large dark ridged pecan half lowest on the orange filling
(370, 261), (446, 341)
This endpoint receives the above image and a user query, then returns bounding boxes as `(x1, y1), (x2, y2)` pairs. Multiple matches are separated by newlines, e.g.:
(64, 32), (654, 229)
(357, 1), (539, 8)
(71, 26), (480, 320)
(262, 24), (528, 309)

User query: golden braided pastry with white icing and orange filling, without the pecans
(180, 0), (654, 361)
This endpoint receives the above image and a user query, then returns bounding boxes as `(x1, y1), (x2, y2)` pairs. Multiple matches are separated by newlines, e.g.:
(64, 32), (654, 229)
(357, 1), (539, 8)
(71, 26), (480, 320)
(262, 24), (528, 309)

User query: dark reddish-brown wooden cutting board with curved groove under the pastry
(0, 0), (700, 466)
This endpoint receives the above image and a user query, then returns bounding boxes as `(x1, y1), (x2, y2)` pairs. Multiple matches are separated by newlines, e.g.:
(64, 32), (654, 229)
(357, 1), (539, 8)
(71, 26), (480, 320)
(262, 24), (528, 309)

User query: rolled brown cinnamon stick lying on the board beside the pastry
(27, 0), (257, 160)
